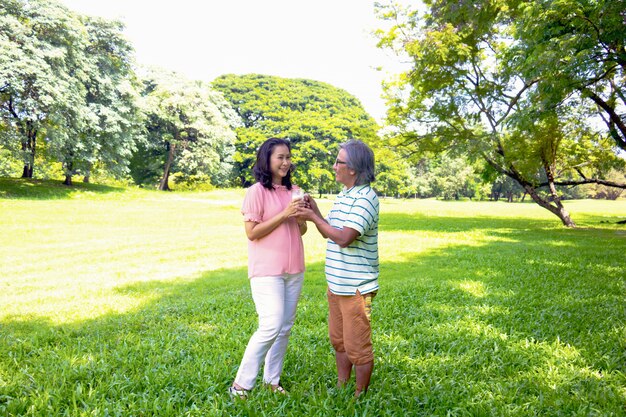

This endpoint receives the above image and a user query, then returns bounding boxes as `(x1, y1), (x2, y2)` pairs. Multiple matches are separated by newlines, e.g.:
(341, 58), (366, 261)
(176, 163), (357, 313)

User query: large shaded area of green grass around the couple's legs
(0, 218), (626, 416)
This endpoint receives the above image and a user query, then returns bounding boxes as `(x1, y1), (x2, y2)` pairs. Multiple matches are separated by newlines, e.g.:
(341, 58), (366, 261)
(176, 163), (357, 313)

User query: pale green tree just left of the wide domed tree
(134, 69), (240, 190)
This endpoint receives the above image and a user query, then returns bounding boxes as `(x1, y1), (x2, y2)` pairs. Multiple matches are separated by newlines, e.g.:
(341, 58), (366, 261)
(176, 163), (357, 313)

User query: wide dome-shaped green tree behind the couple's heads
(213, 74), (378, 192)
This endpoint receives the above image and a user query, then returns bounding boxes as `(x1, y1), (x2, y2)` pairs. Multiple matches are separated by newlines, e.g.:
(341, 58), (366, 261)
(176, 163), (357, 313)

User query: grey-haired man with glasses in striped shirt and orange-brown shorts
(298, 140), (379, 396)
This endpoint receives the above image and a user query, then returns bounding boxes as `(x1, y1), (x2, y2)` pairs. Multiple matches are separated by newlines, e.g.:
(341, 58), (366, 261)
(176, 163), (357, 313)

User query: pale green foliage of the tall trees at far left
(0, 0), (139, 182)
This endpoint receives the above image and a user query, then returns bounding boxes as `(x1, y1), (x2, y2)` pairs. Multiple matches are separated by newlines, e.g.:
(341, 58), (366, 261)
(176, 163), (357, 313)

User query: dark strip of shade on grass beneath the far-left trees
(0, 178), (125, 200)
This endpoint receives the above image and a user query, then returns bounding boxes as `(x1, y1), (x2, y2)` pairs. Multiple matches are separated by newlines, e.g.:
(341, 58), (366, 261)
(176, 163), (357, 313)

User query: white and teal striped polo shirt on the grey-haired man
(325, 184), (379, 295)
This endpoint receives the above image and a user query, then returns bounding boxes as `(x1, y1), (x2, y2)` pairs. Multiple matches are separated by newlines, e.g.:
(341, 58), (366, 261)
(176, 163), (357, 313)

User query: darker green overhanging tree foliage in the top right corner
(511, 0), (626, 150)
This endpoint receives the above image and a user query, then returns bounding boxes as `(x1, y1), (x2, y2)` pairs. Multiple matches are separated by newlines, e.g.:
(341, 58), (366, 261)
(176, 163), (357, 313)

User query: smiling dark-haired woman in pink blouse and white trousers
(229, 138), (306, 397)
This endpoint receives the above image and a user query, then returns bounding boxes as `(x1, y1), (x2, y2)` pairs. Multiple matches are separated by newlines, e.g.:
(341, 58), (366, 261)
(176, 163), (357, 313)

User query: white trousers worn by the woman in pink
(235, 273), (304, 389)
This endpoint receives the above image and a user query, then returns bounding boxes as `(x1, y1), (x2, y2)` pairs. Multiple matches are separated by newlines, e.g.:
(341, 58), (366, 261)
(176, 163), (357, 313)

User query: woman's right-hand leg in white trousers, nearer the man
(263, 273), (304, 385)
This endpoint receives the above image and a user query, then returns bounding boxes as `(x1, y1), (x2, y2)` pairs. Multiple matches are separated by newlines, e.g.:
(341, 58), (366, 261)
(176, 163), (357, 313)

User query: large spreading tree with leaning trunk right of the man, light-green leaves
(372, 0), (624, 226)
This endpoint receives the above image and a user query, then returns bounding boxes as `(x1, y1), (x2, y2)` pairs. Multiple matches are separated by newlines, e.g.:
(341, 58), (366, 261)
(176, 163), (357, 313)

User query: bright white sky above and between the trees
(61, 0), (401, 122)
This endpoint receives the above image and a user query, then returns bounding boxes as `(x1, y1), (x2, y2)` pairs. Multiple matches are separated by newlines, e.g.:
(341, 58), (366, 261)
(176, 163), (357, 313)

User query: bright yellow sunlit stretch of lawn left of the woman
(0, 190), (247, 324)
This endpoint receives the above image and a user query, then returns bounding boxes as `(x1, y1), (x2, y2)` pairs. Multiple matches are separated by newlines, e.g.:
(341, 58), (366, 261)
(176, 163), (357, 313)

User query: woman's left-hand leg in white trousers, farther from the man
(235, 277), (285, 389)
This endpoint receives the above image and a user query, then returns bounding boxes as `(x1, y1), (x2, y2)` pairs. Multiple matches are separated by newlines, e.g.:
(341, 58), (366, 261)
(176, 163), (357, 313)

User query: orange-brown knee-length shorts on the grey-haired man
(326, 290), (376, 365)
